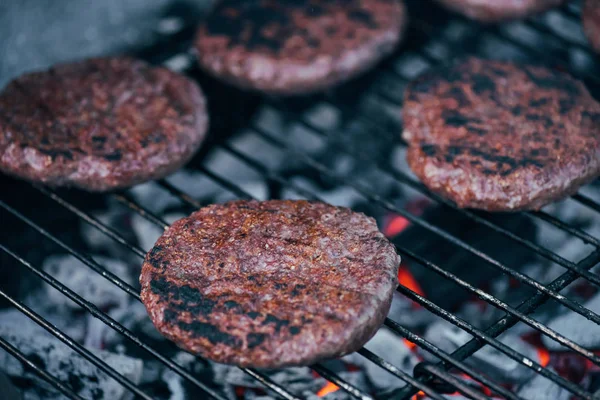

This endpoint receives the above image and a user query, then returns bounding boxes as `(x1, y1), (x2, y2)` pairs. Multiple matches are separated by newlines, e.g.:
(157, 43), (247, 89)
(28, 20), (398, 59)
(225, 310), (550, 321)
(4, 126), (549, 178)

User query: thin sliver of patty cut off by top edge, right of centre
(437, 0), (565, 22)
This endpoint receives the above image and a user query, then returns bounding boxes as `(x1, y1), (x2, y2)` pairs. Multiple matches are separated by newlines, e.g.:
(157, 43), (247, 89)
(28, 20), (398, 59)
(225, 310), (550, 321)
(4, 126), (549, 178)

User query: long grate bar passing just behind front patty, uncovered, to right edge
(247, 127), (600, 324)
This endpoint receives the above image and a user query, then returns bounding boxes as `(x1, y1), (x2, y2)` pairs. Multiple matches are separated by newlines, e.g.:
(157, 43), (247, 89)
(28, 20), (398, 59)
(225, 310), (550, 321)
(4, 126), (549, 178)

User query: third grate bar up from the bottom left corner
(0, 243), (227, 400)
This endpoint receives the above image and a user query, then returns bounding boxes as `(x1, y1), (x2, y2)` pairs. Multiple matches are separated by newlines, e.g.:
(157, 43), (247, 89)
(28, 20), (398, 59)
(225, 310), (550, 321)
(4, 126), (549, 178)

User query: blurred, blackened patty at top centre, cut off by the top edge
(196, 0), (406, 95)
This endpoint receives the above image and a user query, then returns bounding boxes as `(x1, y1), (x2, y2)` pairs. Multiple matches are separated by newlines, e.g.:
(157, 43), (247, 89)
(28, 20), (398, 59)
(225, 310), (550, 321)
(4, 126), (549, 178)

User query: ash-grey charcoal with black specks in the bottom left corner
(0, 310), (143, 400)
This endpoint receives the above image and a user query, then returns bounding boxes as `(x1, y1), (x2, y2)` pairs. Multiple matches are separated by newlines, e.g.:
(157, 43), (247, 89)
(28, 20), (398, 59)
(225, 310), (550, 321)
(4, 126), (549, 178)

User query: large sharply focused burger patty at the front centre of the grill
(140, 200), (400, 368)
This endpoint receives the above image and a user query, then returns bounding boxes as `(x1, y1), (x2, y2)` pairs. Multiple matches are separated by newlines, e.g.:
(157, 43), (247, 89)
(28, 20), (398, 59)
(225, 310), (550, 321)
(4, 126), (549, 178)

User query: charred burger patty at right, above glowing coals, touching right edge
(403, 58), (600, 211)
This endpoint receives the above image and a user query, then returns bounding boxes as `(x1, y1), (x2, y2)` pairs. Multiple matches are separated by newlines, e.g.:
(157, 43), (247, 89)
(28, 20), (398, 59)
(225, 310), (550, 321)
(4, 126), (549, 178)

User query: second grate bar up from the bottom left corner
(0, 289), (152, 400)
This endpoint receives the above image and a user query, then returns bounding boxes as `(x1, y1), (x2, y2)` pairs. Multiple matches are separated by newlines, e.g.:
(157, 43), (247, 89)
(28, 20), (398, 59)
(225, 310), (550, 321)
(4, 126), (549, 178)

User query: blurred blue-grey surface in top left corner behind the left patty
(0, 0), (212, 87)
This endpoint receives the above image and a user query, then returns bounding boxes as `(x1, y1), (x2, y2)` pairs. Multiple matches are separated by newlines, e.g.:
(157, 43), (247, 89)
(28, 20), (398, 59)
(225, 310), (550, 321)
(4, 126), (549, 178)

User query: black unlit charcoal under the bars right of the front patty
(394, 206), (536, 311)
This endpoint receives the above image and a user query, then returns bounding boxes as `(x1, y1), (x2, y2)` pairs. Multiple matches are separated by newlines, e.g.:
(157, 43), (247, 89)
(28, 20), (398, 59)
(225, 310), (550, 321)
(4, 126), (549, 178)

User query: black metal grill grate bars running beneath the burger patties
(0, 0), (600, 400)
